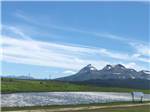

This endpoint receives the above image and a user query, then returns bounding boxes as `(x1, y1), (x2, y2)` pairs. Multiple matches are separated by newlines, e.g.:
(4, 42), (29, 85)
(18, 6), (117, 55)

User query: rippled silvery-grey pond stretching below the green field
(1, 92), (150, 107)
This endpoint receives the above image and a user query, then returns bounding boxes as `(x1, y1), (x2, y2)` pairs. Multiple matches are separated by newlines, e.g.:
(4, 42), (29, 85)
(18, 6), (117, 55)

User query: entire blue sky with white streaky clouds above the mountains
(1, 2), (150, 78)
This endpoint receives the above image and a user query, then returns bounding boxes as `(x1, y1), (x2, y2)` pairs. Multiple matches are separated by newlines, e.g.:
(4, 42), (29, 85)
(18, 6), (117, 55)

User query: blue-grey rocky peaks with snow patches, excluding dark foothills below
(57, 64), (150, 81)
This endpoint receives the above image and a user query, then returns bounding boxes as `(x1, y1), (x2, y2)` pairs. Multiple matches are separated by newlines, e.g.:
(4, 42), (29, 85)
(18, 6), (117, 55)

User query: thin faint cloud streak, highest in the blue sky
(15, 11), (142, 44)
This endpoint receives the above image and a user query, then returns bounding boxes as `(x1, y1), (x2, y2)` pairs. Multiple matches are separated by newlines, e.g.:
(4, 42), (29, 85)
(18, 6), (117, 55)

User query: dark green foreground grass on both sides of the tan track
(1, 101), (149, 112)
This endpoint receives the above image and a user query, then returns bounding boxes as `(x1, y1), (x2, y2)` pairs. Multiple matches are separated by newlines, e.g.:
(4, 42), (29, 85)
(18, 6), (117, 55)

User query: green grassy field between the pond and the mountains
(1, 78), (150, 93)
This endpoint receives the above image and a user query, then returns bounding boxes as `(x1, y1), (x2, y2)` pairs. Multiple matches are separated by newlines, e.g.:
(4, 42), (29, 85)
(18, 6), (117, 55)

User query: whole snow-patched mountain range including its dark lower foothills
(55, 64), (150, 89)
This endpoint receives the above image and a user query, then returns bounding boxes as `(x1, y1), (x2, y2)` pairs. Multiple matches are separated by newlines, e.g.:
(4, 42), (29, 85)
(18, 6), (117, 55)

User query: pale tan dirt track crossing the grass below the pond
(2, 103), (150, 112)
